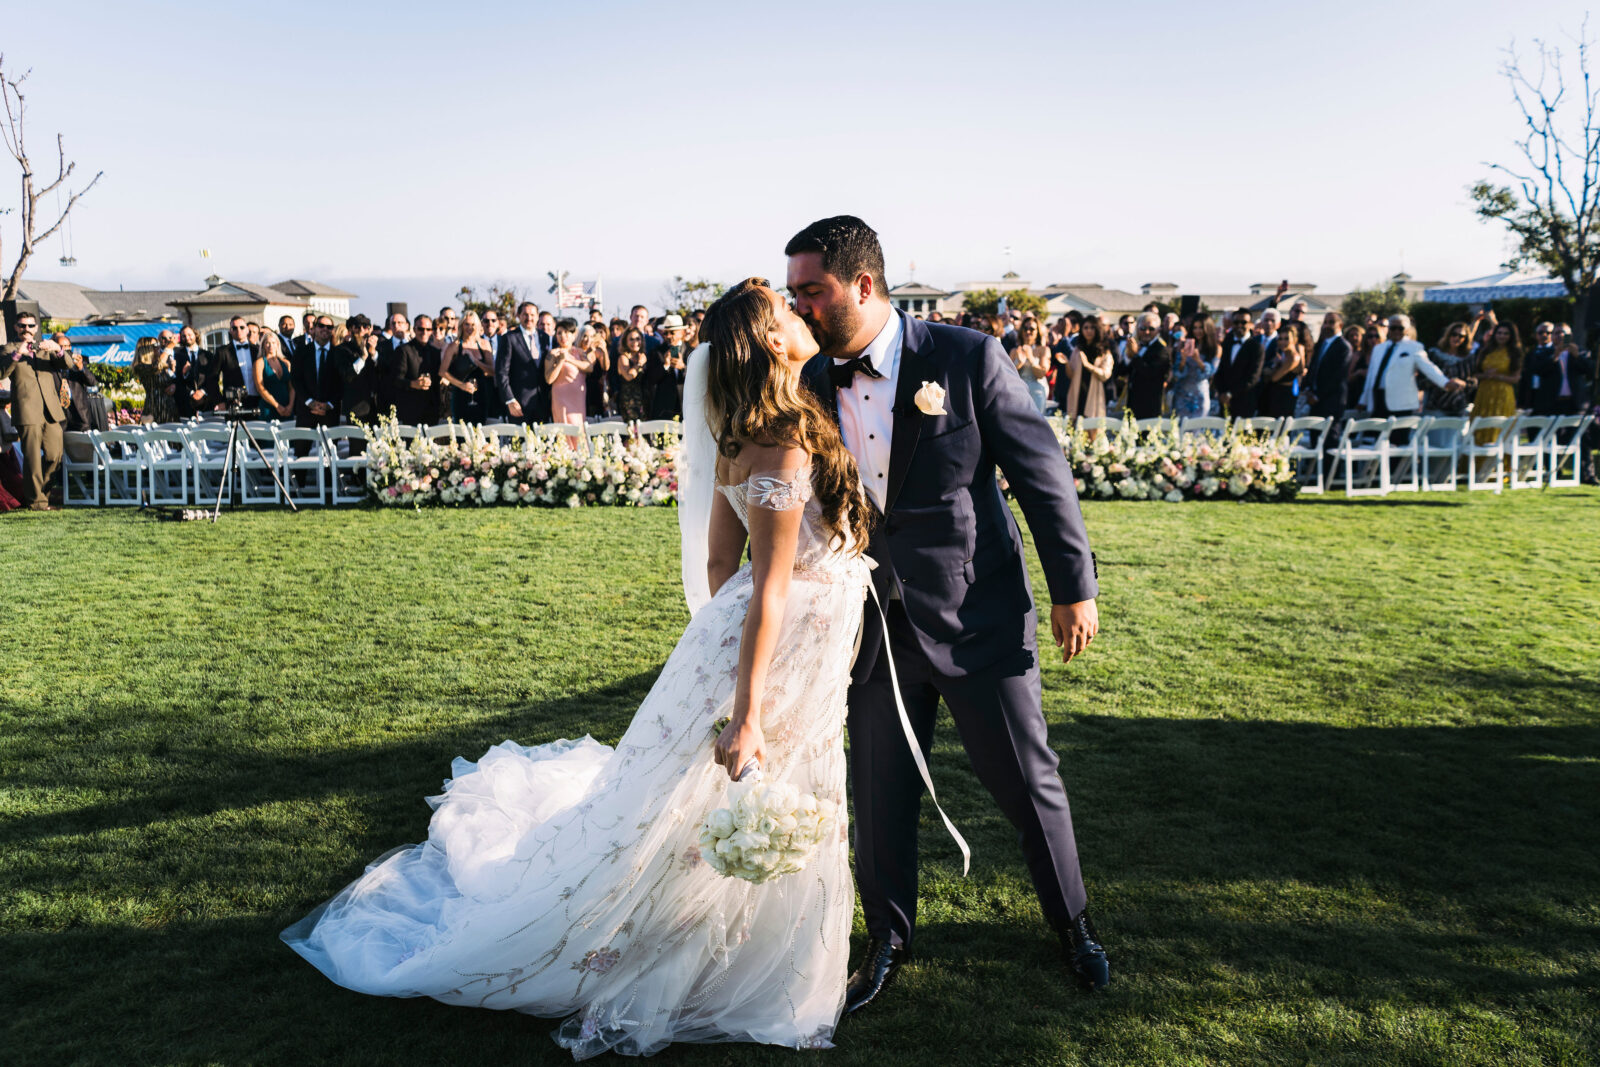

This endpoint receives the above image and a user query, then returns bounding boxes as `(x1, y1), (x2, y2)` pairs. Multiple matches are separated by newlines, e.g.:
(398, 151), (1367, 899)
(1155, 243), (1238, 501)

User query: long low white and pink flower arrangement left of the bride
(366, 419), (678, 507)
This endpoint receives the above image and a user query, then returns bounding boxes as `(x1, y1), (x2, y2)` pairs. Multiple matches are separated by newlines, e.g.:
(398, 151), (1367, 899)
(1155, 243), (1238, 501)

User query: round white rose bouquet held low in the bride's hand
(699, 782), (837, 881)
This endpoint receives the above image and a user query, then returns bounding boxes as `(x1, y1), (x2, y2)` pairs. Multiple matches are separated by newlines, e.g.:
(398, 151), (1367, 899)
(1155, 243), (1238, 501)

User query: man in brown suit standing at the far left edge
(0, 312), (70, 512)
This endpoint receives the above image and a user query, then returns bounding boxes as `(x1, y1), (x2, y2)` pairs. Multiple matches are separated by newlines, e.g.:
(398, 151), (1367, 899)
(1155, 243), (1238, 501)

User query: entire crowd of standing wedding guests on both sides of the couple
(0, 289), (1595, 509)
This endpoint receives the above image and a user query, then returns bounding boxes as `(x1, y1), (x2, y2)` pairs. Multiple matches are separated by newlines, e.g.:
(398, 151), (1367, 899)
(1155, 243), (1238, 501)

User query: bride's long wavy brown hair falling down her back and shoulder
(699, 278), (875, 555)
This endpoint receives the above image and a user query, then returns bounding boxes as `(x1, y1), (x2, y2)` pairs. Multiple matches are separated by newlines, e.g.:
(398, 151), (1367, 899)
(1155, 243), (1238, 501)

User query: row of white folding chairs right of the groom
(1049, 414), (1594, 496)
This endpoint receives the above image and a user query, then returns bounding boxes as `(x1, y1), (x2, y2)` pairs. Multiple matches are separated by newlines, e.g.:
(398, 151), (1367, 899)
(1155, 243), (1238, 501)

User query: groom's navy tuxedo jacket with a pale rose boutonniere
(805, 312), (1099, 681)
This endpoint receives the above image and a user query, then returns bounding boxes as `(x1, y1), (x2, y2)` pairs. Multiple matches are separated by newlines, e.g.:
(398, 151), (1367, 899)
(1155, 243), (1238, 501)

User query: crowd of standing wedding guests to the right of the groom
(963, 302), (1594, 419)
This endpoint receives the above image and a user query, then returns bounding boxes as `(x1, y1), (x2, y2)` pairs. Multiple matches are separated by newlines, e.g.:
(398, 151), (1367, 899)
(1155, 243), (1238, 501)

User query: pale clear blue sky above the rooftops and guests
(0, 0), (1582, 310)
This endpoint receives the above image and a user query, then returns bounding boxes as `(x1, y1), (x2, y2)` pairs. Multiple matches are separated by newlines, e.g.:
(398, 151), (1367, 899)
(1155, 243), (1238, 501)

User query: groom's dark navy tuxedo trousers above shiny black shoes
(845, 600), (1086, 945)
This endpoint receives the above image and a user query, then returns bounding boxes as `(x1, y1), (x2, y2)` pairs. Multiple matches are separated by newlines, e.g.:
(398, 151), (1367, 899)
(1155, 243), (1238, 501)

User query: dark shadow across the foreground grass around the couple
(0, 700), (1600, 1065)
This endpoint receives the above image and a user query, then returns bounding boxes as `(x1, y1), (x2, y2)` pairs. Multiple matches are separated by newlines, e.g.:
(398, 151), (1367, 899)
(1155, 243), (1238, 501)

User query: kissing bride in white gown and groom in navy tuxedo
(283, 216), (1110, 1059)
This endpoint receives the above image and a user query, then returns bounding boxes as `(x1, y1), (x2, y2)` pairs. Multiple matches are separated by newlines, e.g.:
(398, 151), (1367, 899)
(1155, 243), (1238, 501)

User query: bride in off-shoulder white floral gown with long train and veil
(283, 278), (870, 1059)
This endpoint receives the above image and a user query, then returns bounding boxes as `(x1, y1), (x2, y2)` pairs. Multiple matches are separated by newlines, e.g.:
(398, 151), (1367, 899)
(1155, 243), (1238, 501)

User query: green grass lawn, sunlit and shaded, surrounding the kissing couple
(0, 490), (1600, 1067)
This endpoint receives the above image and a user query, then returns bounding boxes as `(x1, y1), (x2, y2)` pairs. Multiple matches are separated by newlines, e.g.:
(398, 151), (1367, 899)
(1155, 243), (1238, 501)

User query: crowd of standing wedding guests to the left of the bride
(123, 302), (704, 427)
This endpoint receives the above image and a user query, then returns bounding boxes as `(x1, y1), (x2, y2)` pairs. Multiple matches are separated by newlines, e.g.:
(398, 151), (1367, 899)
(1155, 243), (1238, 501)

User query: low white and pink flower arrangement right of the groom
(1051, 419), (1299, 504)
